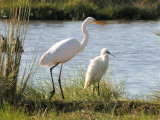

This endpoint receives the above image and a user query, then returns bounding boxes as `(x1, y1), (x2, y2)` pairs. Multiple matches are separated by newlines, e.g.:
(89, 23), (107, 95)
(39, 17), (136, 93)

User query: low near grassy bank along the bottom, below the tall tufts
(0, 82), (160, 120)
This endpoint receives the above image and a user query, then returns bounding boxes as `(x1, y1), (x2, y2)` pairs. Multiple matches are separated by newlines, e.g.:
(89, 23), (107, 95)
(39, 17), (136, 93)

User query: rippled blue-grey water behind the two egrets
(0, 21), (160, 96)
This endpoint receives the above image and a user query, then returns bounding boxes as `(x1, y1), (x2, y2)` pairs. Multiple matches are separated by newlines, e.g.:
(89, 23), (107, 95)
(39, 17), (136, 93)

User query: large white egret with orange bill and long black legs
(40, 17), (105, 100)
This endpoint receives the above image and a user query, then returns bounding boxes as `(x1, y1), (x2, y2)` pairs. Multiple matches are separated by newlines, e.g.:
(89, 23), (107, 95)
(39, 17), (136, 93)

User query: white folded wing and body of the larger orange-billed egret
(40, 38), (80, 66)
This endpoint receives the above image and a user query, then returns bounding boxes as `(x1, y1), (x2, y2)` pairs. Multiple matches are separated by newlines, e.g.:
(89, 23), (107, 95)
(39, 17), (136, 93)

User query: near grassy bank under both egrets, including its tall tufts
(0, 70), (160, 120)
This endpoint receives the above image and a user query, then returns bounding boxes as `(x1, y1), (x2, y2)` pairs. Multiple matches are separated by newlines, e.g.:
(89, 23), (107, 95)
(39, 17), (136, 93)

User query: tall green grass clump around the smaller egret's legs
(61, 69), (125, 101)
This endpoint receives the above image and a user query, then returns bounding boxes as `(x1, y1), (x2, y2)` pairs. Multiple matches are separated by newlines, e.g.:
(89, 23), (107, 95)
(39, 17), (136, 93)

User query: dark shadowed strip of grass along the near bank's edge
(18, 100), (160, 115)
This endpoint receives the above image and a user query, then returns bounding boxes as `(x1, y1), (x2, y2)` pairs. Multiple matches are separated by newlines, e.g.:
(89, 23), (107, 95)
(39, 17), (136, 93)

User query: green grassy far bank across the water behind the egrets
(30, 1), (160, 20)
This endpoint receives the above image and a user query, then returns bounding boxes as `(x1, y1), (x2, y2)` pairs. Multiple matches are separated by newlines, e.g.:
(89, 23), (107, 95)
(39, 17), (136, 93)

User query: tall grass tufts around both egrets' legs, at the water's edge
(26, 68), (126, 102)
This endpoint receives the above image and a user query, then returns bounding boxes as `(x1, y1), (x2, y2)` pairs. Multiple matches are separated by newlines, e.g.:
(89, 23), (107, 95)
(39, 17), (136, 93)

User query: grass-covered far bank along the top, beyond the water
(1, 0), (160, 20)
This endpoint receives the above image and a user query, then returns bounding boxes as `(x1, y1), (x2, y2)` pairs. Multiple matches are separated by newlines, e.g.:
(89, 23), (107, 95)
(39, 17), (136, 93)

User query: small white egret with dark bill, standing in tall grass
(84, 48), (115, 95)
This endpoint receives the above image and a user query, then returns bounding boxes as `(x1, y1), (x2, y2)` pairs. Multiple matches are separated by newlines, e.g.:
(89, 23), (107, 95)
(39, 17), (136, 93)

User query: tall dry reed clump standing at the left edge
(0, 0), (30, 103)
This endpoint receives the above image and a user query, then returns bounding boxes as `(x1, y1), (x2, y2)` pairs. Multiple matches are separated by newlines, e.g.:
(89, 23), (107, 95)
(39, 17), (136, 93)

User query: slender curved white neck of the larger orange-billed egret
(80, 22), (89, 51)
